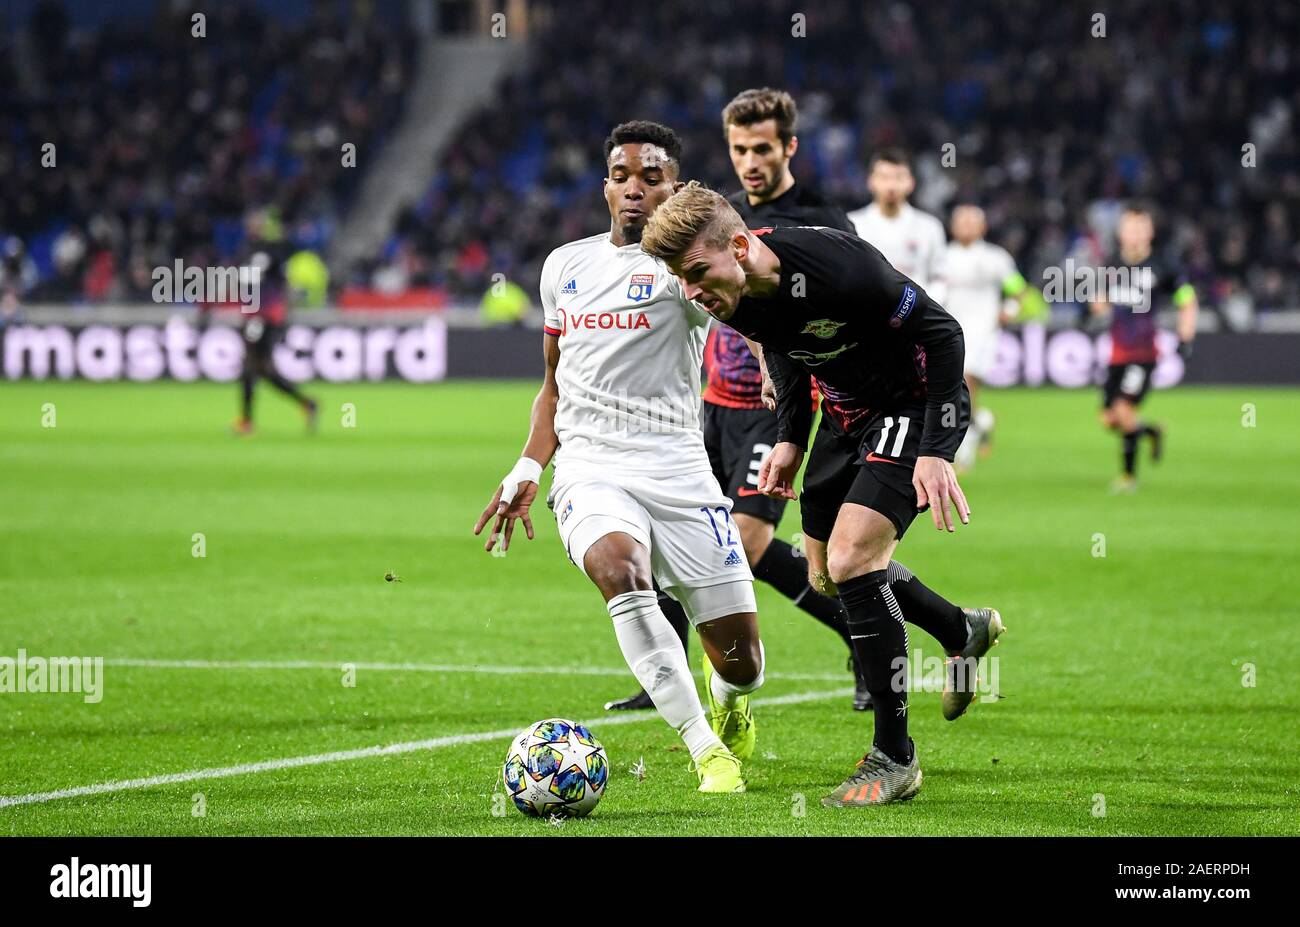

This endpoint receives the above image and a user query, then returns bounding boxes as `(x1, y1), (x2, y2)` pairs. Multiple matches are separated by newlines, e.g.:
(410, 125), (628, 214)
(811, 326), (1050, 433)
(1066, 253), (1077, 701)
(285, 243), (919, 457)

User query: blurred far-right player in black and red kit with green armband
(1091, 204), (1199, 493)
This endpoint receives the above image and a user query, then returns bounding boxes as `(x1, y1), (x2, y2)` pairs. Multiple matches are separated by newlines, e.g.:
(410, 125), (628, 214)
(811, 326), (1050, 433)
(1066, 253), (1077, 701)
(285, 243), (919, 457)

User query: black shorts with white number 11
(800, 406), (930, 541)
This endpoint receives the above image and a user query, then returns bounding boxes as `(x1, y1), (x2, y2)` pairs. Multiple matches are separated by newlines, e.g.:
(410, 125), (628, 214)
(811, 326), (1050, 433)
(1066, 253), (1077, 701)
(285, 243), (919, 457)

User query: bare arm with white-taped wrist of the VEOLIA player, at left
(475, 334), (560, 550)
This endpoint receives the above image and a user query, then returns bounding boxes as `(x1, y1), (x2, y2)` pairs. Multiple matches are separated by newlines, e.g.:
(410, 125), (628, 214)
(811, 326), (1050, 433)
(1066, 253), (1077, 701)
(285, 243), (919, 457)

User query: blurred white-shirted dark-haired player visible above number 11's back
(849, 148), (946, 306)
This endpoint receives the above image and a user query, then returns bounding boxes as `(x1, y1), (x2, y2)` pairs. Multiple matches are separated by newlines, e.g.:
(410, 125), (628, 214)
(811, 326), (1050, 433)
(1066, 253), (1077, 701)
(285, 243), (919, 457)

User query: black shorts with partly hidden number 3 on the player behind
(699, 402), (785, 525)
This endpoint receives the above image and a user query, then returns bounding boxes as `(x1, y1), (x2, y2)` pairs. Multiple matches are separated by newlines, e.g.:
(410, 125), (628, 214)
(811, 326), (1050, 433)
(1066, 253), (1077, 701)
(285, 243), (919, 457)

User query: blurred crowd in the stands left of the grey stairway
(0, 0), (417, 310)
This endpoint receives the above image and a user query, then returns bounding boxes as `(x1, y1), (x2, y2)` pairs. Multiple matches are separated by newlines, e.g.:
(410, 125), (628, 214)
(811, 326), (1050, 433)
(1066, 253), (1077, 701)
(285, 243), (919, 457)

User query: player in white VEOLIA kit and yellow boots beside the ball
(475, 121), (763, 792)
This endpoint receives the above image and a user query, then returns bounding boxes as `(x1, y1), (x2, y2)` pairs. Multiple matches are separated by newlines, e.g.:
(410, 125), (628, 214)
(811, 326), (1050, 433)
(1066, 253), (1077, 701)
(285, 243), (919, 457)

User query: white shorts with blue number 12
(546, 471), (758, 624)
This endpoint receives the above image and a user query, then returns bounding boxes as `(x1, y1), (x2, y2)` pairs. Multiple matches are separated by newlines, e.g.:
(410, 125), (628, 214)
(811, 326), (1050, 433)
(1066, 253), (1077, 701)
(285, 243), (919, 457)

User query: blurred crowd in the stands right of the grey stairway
(374, 0), (1300, 322)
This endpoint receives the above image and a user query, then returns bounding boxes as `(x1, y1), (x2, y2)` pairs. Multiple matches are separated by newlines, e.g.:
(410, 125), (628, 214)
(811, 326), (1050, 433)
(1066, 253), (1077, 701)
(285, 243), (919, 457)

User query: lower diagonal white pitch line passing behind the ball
(0, 689), (853, 807)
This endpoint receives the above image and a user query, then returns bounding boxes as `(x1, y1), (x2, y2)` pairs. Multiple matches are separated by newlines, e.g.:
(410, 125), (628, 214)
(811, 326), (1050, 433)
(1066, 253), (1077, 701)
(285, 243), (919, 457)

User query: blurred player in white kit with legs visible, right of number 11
(944, 203), (1030, 471)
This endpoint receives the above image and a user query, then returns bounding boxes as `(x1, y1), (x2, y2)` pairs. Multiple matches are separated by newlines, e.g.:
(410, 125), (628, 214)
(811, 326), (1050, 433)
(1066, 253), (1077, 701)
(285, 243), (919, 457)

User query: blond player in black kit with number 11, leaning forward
(641, 183), (1004, 806)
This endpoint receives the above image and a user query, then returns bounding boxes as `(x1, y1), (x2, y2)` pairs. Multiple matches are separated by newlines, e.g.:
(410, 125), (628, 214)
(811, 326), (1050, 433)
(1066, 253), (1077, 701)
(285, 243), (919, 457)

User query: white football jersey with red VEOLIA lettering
(541, 231), (710, 476)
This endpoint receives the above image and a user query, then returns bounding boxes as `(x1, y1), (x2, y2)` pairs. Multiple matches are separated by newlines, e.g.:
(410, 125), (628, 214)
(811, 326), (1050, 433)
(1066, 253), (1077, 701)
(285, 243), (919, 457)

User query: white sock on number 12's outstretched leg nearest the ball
(606, 589), (722, 759)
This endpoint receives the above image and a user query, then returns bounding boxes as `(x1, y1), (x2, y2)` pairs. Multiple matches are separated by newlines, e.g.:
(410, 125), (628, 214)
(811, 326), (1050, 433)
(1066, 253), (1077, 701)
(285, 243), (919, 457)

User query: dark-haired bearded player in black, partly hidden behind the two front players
(605, 87), (871, 711)
